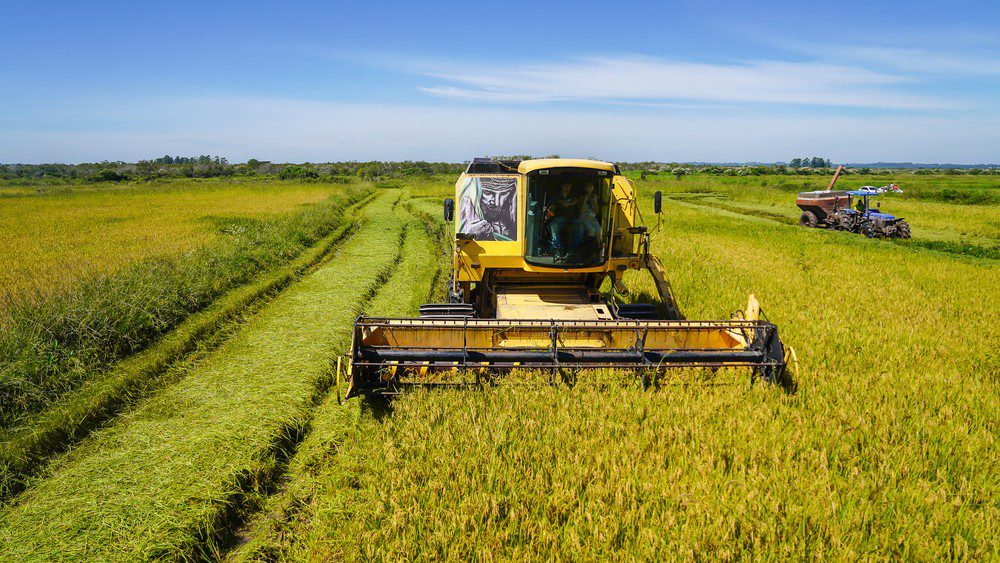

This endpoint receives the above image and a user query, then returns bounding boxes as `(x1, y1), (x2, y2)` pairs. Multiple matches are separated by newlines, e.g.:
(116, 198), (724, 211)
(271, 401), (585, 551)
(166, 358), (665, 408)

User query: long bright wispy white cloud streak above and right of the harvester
(417, 55), (956, 110)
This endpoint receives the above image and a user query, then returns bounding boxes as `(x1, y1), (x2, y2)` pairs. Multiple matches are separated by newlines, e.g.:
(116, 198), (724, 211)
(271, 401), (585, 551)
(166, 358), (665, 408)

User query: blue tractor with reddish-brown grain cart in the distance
(795, 166), (910, 238)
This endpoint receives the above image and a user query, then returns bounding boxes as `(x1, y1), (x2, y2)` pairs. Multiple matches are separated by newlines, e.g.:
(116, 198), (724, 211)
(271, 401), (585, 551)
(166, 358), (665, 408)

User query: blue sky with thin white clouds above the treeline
(0, 0), (1000, 163)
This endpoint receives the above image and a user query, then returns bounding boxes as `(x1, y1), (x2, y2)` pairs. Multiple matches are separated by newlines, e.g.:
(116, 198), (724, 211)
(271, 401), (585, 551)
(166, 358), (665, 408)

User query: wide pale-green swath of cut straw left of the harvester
(0, 191), (403, 560)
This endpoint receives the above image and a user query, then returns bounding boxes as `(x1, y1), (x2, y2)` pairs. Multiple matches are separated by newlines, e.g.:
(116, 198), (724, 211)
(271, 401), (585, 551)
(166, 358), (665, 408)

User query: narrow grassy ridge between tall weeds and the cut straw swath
(0, 197), (371, 499)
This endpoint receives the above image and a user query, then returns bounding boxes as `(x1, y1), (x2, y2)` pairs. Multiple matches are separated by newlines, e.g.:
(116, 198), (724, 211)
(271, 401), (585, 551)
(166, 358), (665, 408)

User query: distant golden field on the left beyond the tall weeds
(0, 179), (352, 299)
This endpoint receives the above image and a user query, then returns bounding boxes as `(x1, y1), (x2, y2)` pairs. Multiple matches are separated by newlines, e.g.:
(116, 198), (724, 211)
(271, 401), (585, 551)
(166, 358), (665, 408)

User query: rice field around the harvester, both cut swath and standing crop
(0, 175), (1000, 561)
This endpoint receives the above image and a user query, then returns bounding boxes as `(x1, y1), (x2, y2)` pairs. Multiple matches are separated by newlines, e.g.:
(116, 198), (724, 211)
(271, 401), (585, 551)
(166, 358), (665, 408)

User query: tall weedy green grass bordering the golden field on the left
(0, 183), (363, 427)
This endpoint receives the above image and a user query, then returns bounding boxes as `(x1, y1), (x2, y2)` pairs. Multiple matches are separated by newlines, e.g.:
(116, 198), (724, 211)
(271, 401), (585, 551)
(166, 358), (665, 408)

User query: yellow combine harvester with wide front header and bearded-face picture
(338, 158), (794, 397)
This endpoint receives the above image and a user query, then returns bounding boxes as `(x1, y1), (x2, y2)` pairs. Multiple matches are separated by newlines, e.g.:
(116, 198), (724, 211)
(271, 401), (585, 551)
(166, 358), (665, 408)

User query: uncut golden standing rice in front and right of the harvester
(236, 178), (1000, 560)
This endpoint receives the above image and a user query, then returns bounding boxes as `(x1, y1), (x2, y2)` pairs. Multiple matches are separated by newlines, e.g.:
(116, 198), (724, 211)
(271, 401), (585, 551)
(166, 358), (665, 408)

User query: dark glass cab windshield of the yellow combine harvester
(525, 169), (611, 268)
